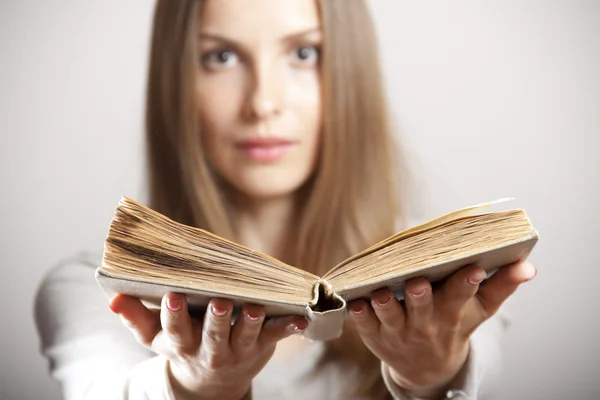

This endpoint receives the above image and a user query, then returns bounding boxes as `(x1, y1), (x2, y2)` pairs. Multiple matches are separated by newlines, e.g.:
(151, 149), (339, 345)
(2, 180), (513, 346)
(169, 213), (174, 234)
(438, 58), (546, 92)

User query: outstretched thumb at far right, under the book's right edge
(476, 262), (537, 318)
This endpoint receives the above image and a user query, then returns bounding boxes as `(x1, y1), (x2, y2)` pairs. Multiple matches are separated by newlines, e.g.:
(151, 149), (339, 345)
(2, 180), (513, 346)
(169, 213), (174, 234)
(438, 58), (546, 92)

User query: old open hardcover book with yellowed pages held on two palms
(96, 197), (538, 340)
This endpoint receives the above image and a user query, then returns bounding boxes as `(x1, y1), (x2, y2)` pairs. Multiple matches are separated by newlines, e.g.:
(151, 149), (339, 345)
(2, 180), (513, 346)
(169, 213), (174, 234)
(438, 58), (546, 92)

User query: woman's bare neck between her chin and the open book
(235, 196), (296, 262)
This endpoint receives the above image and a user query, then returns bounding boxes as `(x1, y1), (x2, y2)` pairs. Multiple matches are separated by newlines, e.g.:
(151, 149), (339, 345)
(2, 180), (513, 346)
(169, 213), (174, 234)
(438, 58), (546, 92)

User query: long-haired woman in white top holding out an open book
(37, 0), (535, 399)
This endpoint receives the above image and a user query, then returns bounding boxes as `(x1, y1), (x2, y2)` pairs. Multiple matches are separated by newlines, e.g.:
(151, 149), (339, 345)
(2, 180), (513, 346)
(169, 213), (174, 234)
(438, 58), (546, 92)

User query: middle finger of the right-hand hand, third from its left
(404, 278), (433, 338)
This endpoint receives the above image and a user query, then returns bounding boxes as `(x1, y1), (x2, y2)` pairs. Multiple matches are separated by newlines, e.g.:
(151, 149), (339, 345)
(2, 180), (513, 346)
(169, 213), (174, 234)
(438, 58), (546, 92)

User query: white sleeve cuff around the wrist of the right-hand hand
(381, 310), (508, 400)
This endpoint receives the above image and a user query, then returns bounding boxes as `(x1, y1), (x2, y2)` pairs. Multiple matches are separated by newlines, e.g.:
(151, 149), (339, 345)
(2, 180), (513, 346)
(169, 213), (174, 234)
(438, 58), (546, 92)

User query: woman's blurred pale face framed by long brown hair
(197, 0), (322, 199)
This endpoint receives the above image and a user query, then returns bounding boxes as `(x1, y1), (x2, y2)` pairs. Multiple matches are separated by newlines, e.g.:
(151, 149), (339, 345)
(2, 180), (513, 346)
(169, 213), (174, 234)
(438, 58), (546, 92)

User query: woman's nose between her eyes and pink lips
(246, 61), (285, 120)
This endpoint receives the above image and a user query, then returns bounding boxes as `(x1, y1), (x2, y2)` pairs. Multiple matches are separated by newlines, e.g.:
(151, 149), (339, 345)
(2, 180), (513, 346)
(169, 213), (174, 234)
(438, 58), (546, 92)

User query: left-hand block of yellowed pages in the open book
(101, 198), (319, 302)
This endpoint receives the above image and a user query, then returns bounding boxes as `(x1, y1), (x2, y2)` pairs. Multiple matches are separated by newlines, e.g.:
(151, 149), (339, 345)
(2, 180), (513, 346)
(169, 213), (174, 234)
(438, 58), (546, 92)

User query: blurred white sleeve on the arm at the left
(35, 259), (174, 400)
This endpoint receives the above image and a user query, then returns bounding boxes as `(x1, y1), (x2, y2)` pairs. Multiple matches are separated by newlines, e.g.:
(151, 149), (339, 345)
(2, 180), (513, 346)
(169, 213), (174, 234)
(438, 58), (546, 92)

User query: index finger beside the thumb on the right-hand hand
(434, 265), (486, 326)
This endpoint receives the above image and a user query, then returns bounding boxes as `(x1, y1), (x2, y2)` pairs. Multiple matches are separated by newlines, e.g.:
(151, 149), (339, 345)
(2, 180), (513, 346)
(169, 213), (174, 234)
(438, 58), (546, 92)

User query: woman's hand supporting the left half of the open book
(109, 293), (308, 400)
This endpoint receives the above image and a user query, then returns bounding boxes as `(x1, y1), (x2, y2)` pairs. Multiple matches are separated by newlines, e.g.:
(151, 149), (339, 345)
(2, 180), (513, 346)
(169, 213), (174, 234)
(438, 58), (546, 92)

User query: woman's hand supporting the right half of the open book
(349, 263), (536, 397)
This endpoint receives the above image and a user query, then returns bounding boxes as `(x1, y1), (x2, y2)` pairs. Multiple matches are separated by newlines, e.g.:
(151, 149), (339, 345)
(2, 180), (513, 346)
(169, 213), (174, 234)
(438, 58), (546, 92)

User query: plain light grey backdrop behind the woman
(0, 0), (600, 400)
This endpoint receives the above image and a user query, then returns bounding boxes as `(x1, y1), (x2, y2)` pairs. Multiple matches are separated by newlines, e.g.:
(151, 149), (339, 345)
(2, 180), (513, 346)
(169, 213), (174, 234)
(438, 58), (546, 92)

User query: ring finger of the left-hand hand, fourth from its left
(229, 304), (265, 354)
